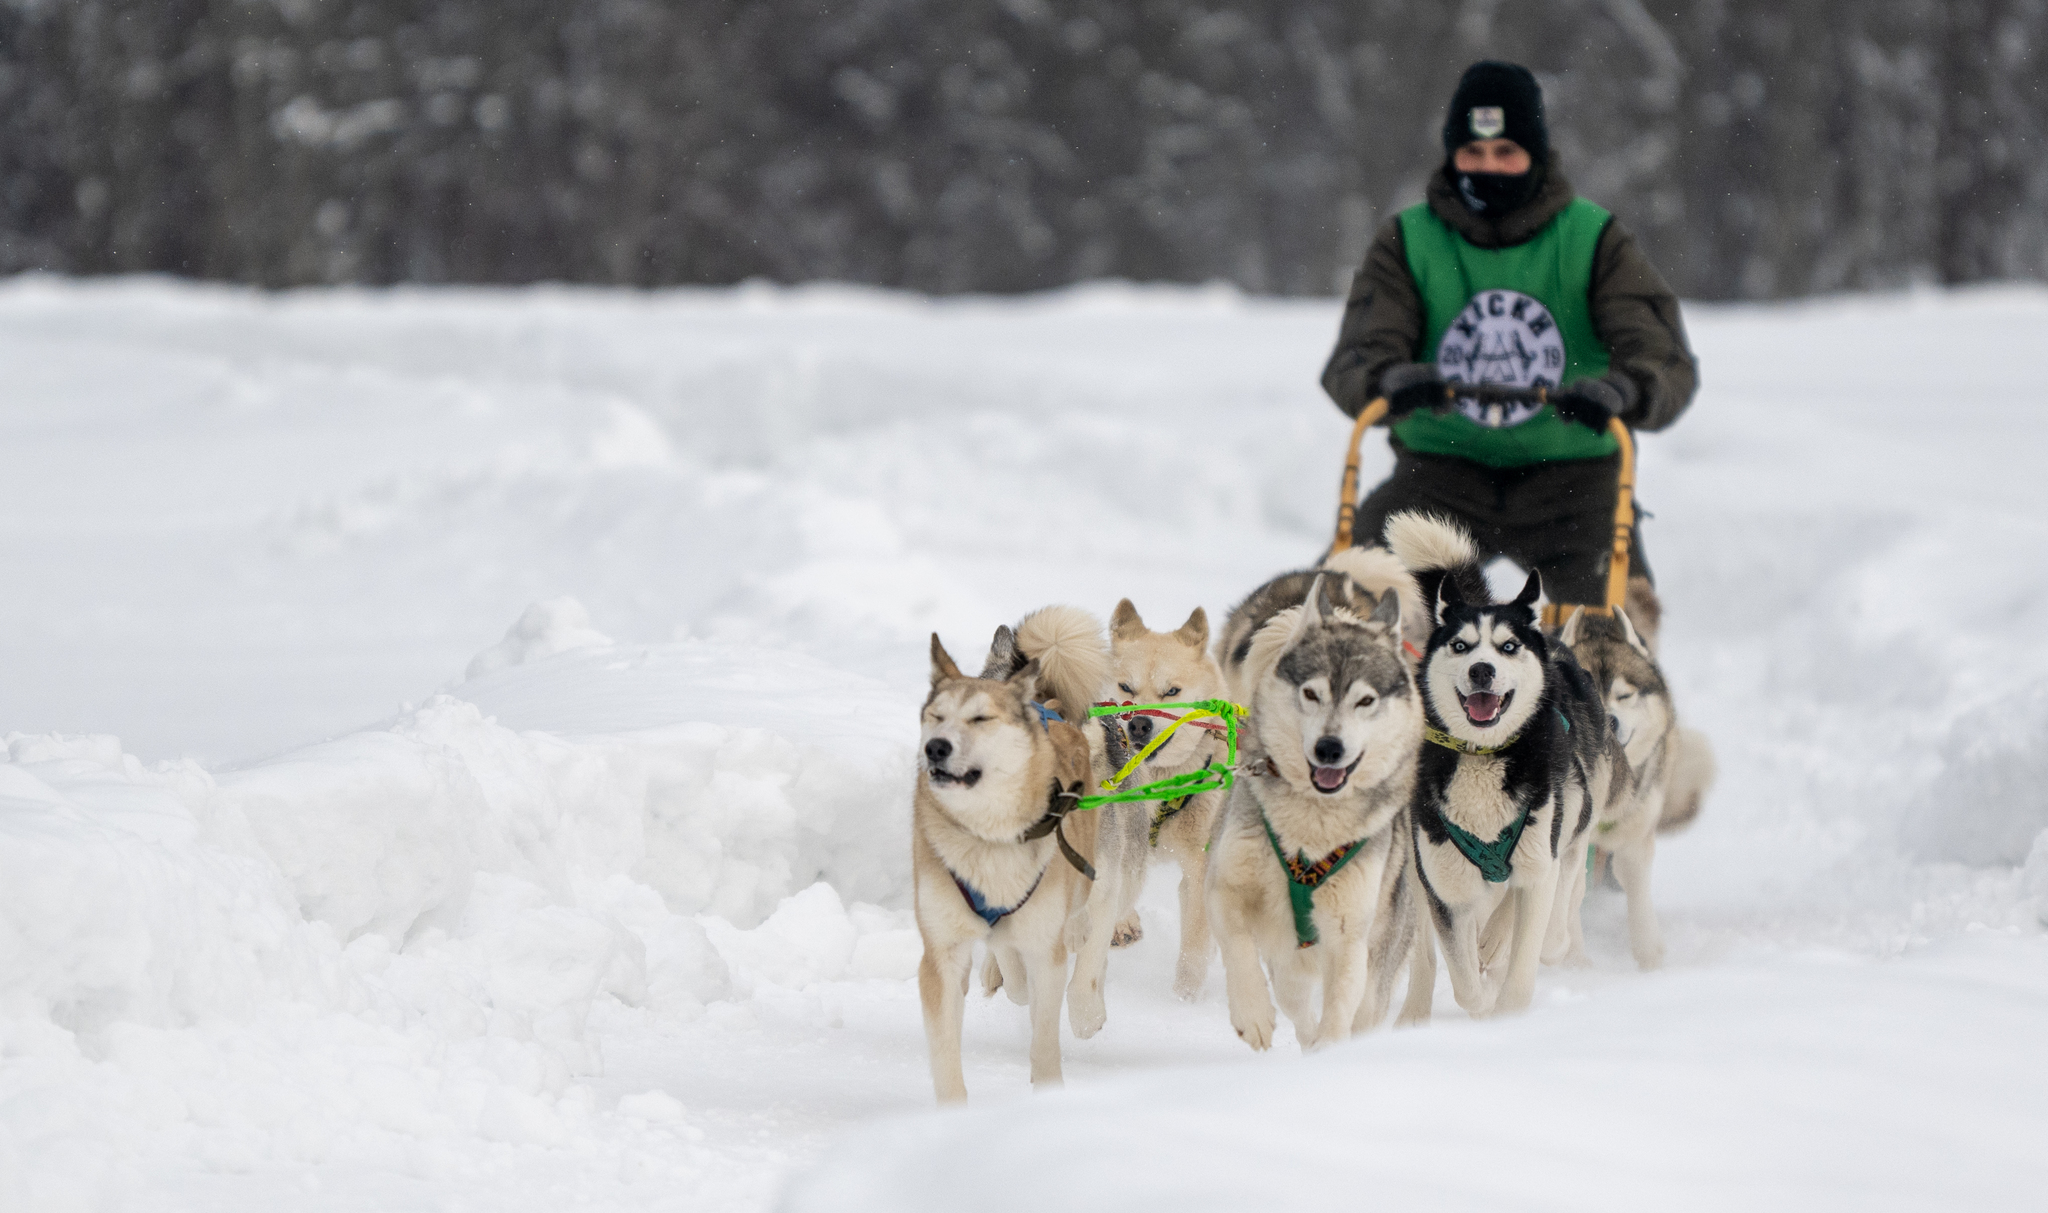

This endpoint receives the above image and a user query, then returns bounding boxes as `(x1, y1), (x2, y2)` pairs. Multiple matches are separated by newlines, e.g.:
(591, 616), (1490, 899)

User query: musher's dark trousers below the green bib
(1352, 441), (1651, 604)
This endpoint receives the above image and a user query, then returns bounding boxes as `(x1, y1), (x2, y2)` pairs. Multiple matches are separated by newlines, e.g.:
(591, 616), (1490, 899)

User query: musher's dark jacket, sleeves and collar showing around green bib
(1323, 166), (1700, 430)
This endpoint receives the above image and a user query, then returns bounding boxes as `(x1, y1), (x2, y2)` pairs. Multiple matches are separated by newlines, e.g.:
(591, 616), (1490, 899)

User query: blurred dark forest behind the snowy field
(0, 0), (2048, 299)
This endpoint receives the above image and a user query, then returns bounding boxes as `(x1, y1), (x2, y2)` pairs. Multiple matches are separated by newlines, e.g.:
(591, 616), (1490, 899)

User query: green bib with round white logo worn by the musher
(1395, 199), (1616, 467)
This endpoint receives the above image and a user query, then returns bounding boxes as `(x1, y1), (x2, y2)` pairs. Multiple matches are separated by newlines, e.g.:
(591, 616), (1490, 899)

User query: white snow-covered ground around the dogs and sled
(0, 279), (2048, 1213)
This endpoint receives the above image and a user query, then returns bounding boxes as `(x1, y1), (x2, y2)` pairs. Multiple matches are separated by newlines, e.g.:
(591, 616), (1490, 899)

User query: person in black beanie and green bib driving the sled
(1323, 59), (1698, 635)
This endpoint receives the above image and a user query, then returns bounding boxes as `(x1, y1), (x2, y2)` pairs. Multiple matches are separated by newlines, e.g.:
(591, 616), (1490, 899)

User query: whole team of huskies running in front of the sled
(911, 514), (1712, 1100)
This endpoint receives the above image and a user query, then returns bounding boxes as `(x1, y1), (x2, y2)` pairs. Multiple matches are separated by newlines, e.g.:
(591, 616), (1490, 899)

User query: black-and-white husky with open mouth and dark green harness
(1386, 512), (1634, 1022)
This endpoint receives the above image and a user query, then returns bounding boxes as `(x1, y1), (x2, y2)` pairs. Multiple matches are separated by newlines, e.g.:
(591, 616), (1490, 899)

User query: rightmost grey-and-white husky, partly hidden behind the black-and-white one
(1544, 607), (1714, 969)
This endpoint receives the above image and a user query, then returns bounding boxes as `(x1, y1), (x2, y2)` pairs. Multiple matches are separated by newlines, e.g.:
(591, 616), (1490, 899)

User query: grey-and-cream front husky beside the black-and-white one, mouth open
(1206, 559), (1423, 1049)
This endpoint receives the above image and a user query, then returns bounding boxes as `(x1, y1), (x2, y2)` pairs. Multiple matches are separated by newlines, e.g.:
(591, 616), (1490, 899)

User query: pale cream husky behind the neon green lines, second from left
(1067, 598), (1229, 1004)
